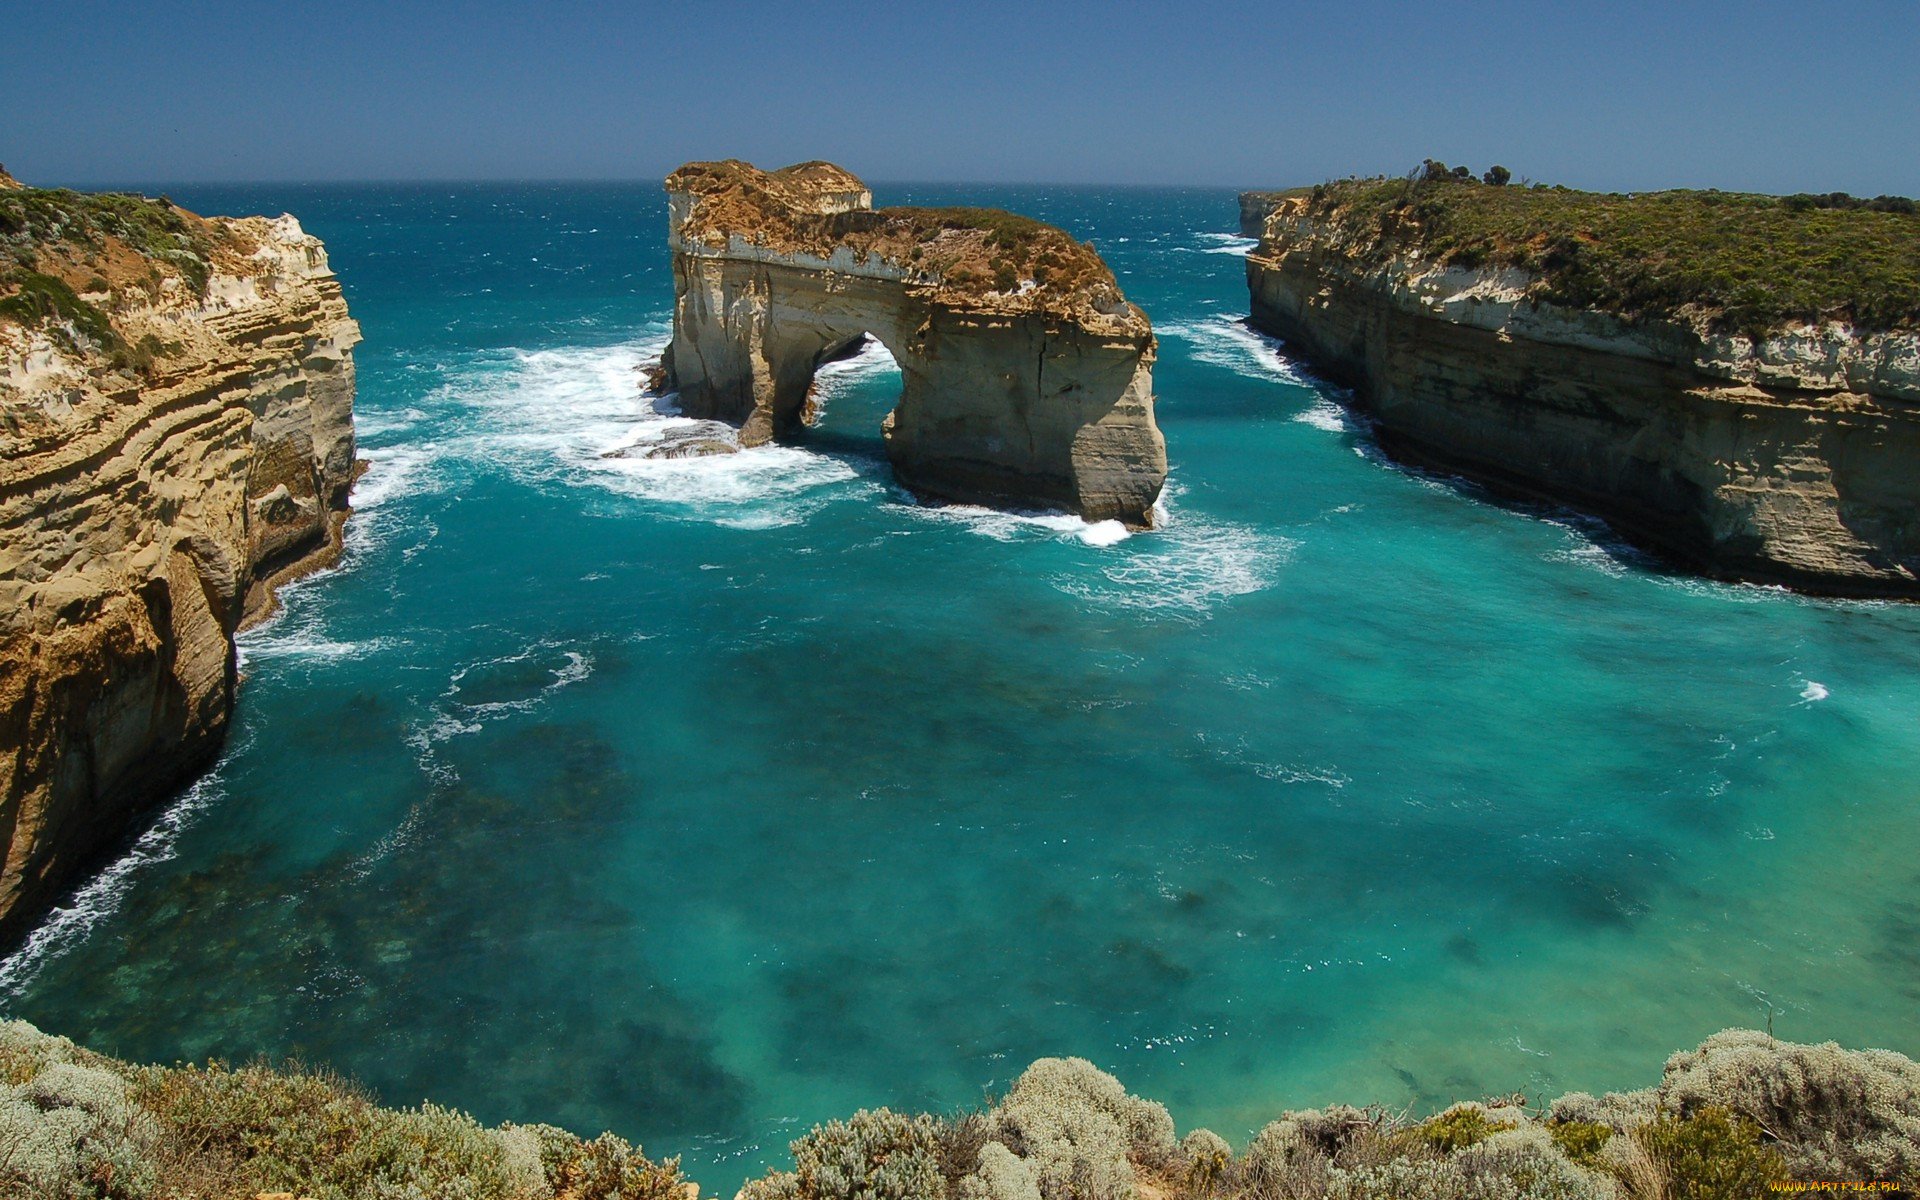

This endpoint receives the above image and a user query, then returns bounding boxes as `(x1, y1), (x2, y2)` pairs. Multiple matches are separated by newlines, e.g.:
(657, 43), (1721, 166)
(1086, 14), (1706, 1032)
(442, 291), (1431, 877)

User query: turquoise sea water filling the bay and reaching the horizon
(0, 186), (1920, 1190)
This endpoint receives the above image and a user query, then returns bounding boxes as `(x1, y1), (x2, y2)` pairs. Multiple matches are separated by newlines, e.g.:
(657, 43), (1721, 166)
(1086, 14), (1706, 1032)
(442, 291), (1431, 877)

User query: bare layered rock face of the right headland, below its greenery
(1246, 198), (1920, 597)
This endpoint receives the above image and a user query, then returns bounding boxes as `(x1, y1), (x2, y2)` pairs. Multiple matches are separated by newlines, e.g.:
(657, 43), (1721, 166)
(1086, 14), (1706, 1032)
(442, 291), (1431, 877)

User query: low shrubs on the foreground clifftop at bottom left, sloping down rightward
(0, 1021), (685, 1200)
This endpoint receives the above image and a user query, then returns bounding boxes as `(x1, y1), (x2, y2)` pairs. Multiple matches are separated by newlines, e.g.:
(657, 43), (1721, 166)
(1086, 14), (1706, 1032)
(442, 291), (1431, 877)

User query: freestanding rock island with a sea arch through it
(662, 161), (1167, 526)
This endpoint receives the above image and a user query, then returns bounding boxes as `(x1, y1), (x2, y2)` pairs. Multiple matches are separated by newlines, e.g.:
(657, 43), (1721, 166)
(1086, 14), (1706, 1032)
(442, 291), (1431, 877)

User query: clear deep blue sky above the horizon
(0, 0), (1920, 194)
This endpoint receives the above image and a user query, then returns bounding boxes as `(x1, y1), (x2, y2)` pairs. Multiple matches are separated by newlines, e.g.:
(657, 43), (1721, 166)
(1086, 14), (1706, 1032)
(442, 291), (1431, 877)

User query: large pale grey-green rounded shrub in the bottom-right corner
(1659, 1029), (1920, 1181)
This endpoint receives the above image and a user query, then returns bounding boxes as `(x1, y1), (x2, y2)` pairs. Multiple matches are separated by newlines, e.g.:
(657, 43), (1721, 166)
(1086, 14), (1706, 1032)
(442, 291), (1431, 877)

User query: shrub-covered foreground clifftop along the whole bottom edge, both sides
(0, 1021), (1920, 1200)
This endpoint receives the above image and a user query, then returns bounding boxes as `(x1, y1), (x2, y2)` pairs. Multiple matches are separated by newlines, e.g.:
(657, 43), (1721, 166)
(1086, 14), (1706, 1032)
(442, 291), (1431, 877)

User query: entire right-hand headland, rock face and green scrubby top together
(1244, 179), (1920, 597)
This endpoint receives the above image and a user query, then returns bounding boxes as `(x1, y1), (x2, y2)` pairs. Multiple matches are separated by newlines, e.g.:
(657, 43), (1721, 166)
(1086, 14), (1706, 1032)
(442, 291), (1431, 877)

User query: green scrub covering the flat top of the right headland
(1298, 159), (1920, 334)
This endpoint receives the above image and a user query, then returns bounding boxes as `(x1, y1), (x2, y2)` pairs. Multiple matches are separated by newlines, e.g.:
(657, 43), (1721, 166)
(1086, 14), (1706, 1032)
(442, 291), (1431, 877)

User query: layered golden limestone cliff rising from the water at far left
(0, 188), (359, 937)
